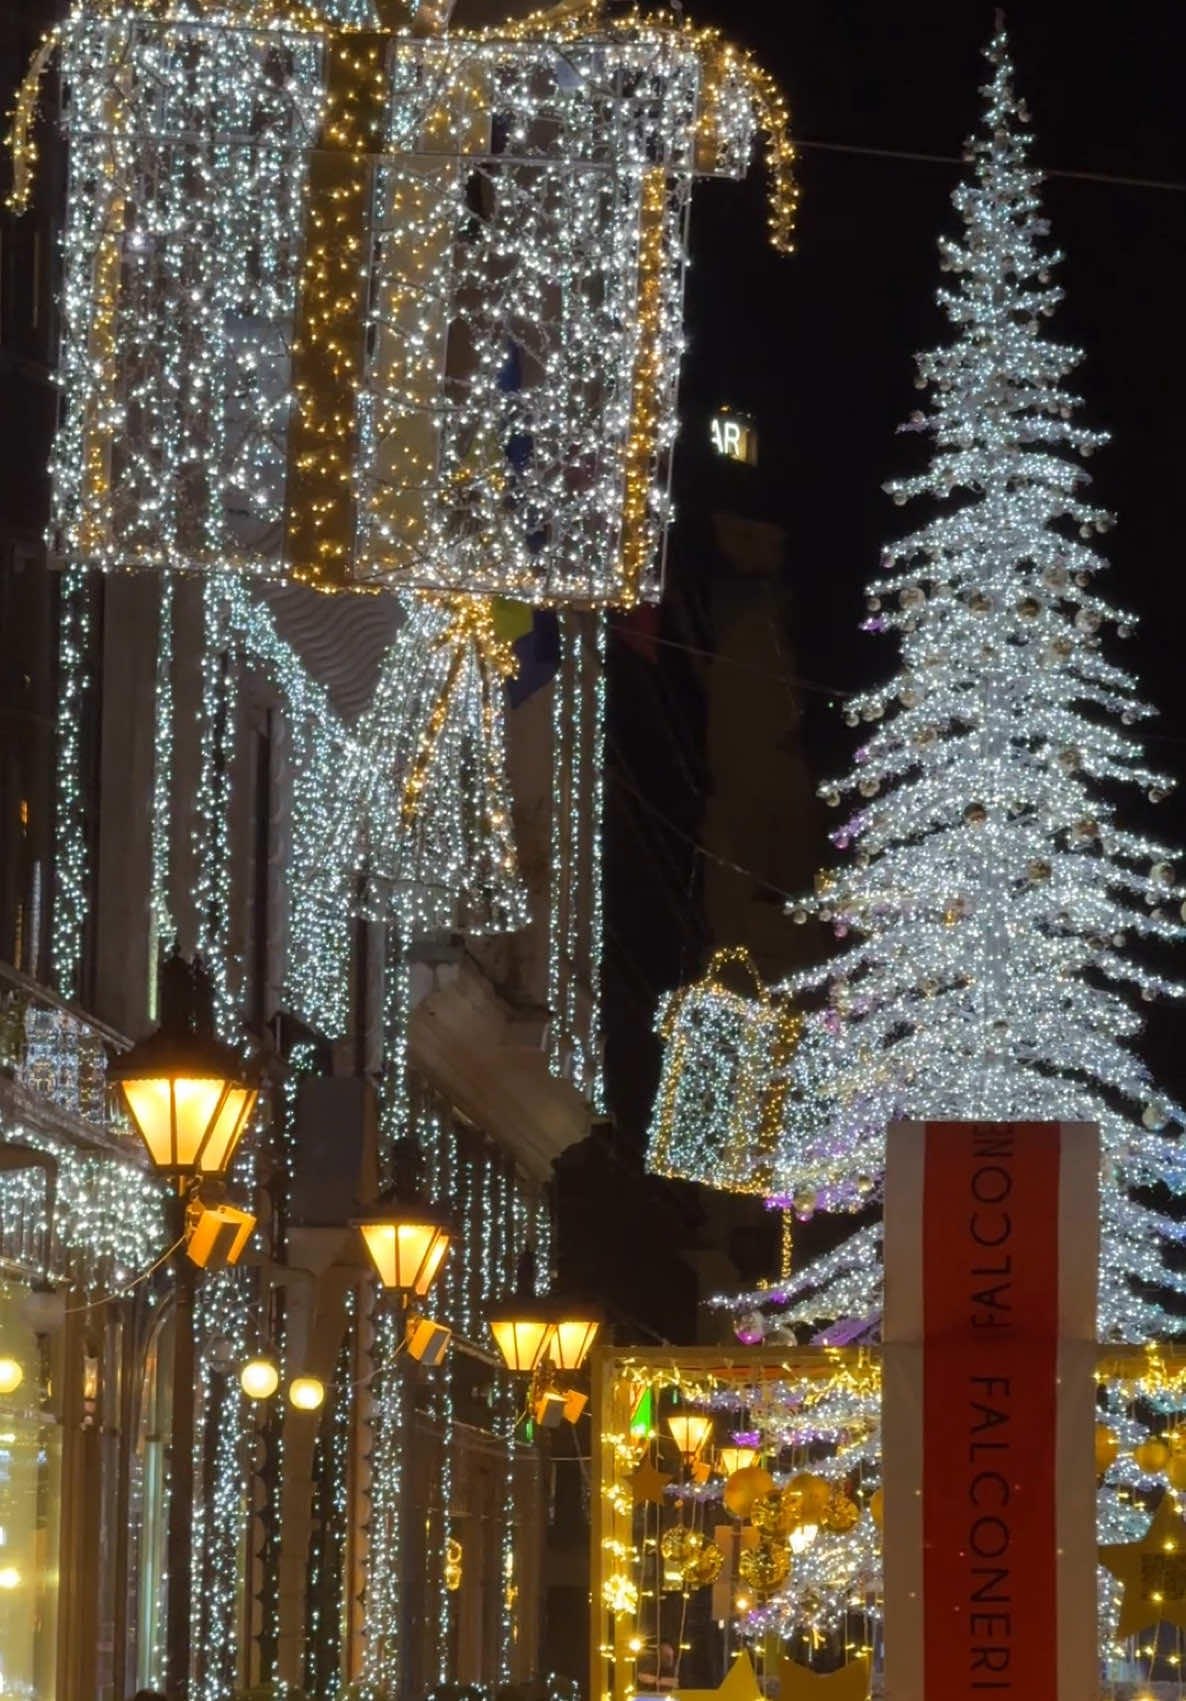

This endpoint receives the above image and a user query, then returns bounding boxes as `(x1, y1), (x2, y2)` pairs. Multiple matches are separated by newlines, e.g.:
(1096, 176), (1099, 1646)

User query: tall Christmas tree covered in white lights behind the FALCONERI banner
(772, 19), (1186, 1339)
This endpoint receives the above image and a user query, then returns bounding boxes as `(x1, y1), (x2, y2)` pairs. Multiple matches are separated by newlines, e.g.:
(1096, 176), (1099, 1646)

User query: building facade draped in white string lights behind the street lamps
(0, 3), (604, 1701)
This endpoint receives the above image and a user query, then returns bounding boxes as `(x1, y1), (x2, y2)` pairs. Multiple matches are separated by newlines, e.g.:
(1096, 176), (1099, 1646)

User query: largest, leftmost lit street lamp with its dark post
(107, 953), (257, 1701)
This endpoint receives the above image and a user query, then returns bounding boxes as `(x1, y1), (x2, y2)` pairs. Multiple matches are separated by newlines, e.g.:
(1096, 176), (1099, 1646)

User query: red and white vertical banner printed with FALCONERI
(883, 1123), (1098, 1701)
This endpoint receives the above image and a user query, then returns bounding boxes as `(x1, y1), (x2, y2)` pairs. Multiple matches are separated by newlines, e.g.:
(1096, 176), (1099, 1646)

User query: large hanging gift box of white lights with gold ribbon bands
(14, 0), (795, 606)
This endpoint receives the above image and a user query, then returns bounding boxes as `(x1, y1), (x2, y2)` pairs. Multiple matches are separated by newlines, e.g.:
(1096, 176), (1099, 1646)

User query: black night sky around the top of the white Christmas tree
(619, 0), (1186, 1090)
